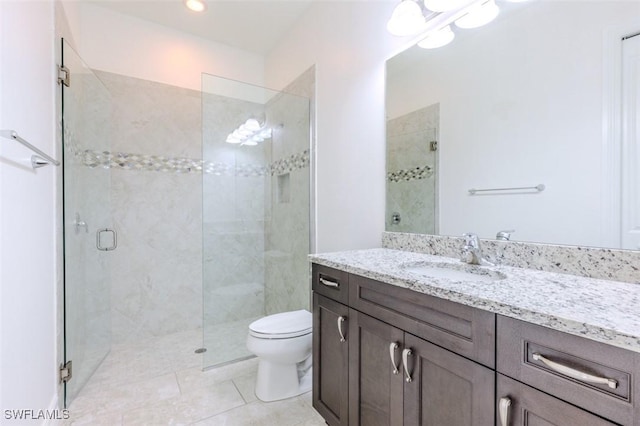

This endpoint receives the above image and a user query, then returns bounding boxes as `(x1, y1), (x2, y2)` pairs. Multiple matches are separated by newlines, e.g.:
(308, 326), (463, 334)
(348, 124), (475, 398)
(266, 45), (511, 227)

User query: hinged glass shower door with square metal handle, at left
(62, 40), (116, 407)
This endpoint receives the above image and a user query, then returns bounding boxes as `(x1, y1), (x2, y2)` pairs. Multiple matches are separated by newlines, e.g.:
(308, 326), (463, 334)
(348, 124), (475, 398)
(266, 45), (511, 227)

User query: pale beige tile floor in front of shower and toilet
(64, 330), (325, 426)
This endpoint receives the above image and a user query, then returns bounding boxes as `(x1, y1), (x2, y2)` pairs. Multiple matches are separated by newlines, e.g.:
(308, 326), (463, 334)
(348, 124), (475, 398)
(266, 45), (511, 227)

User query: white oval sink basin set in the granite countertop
(403, 262), (506, 283)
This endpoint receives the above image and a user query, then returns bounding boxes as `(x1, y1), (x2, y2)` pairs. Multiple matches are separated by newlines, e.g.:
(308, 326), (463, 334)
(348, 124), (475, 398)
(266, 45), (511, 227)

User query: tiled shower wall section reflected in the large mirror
(385, 104), (440, 234)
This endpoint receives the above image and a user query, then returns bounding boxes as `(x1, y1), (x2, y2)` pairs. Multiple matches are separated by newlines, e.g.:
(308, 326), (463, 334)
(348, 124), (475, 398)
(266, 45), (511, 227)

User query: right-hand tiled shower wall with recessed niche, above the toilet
(265, 67), (315, 314)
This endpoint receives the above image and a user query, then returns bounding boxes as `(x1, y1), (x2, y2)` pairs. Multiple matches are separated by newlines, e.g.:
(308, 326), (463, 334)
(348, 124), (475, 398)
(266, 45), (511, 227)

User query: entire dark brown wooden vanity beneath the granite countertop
(312, 263), (640, 426)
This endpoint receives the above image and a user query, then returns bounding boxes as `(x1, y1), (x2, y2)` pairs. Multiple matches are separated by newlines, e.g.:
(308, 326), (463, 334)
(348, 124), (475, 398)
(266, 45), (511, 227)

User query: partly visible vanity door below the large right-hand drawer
(496, 374), (615, 426)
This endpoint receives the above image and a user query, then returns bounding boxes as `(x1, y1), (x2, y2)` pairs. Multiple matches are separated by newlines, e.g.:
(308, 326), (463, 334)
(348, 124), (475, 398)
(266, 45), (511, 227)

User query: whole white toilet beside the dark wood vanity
(247, 309), (313, 402)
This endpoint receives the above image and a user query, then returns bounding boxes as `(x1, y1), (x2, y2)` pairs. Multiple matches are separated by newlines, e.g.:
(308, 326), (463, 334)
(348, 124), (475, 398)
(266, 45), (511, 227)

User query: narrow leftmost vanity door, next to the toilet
(313, 293), (350, 426)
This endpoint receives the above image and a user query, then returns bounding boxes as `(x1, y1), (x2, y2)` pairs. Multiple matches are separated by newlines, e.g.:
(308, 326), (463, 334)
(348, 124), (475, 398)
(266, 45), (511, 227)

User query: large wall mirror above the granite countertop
(386, 0), (640, 250)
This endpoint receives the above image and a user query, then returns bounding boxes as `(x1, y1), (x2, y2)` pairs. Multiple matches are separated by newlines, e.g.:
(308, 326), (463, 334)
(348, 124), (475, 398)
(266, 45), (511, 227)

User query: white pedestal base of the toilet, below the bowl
(255, 360), (313, 402)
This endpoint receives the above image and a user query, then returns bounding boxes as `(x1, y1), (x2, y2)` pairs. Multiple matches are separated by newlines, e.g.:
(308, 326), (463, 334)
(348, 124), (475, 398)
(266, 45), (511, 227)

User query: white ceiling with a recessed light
(85, 0), (317, 55)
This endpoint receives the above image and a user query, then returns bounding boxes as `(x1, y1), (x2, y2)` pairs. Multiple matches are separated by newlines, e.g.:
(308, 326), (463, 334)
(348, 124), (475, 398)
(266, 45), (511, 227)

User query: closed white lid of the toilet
(249, 309), (313, 339)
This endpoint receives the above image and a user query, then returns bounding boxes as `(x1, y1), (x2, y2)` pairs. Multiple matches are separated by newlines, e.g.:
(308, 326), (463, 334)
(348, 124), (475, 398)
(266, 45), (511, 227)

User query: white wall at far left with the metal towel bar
(0, 1), (60, 424)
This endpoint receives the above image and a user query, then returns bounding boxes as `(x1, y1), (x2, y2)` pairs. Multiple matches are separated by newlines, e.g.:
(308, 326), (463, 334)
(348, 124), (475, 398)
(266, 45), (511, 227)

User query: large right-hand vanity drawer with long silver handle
(497, 315), (640, 425)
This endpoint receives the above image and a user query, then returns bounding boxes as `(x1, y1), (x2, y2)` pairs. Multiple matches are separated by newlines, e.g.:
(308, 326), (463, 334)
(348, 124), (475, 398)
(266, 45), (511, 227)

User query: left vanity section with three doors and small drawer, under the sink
(313, 265), (495, 426)
